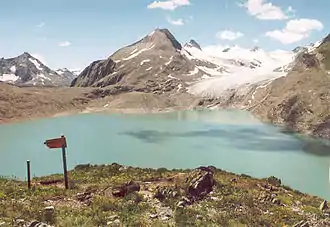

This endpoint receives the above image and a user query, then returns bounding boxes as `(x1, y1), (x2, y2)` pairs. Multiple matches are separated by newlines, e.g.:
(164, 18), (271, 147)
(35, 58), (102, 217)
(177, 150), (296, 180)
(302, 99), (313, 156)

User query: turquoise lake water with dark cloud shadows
(0, 110), (330, 199)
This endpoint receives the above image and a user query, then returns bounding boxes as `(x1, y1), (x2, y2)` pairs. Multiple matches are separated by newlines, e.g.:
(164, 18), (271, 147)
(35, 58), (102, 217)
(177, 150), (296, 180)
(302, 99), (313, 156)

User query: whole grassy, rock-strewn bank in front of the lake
(0, 163), (330, 227)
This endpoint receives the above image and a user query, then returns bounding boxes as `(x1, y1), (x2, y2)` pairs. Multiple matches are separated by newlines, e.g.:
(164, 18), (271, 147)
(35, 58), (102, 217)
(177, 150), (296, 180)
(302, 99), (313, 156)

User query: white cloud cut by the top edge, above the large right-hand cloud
(240, 0), (293, 20)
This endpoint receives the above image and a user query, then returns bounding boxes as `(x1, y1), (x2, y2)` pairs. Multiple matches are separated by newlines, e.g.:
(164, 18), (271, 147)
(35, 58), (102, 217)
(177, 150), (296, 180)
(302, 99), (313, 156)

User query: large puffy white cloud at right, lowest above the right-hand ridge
(265, 19), (323, 44)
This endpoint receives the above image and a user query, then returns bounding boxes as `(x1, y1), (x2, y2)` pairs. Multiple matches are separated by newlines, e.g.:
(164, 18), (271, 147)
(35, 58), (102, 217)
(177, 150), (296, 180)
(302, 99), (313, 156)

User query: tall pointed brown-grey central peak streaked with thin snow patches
(71, 29), (206, 93)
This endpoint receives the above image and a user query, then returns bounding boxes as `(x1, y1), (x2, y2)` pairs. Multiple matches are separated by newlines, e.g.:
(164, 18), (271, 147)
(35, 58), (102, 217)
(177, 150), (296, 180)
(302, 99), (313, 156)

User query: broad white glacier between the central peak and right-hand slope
(182, 42), (295, 97)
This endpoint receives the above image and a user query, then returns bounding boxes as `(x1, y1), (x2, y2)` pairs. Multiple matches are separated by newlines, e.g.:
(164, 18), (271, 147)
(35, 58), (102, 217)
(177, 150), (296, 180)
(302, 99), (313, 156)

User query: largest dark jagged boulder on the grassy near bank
(187, 167), (215, 200)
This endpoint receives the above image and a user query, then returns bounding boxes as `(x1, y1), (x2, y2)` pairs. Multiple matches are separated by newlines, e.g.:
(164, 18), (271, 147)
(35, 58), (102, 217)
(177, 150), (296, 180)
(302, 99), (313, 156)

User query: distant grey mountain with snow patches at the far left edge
(0, 52), (73, 86)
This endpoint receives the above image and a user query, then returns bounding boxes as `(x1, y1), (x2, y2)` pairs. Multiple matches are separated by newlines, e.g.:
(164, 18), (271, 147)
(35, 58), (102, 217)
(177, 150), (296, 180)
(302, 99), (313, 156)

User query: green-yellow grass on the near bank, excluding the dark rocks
(0, 164), (323, 227)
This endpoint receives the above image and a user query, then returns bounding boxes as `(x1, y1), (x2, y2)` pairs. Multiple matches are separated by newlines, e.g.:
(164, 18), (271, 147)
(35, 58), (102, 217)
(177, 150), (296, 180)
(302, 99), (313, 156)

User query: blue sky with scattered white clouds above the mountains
(0, 0), (330, 70)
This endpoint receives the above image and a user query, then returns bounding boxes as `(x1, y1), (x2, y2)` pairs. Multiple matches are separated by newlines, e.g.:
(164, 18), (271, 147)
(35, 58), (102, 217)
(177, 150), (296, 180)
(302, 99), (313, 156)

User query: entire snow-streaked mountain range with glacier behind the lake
(0, 29), (330, 138)
